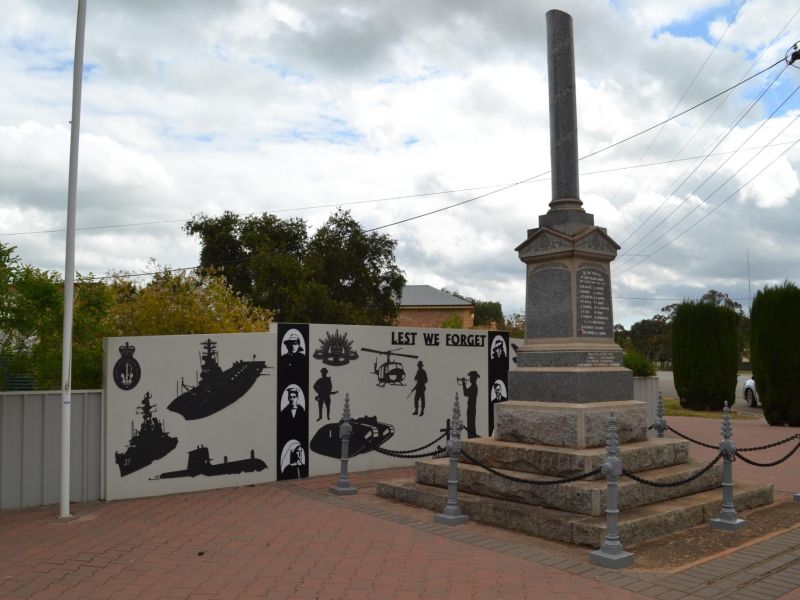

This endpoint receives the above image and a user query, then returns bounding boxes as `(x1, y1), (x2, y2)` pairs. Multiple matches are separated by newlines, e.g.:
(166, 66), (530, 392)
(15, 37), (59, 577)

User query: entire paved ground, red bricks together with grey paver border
(0, 417), (800, 600)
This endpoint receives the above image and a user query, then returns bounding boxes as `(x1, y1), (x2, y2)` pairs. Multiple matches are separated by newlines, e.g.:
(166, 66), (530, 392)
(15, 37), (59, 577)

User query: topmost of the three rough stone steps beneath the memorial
(462, 438), (689, 479)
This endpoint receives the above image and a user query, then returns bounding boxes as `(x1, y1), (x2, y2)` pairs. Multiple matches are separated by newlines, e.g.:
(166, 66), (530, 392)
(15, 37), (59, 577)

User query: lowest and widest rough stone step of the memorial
(376, 479), (773, 549)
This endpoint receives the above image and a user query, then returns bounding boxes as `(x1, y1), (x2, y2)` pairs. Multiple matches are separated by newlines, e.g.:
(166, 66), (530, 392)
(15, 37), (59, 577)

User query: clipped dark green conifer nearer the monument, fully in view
(672, 301), (739, 410)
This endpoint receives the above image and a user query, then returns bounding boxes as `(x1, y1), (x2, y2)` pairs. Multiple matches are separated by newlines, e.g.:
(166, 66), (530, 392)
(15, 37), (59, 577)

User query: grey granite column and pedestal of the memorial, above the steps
(504, 10), (646, 448)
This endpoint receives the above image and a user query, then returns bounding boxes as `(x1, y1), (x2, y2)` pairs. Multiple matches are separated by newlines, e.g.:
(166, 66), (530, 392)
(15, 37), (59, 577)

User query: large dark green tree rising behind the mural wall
(184, 209), (405, 325)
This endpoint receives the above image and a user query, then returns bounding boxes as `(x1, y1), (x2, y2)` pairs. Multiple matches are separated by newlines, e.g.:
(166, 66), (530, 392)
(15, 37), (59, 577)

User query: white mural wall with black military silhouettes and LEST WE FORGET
(105, 323), (513, 499)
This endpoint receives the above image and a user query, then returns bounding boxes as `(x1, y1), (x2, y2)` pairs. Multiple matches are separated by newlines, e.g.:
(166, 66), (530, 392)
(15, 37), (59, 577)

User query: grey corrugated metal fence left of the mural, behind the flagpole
(0, 390), (103, 509)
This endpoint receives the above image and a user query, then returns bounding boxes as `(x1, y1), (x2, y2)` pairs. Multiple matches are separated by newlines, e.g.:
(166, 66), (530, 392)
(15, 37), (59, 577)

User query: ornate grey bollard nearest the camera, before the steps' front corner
(589, 413), (633, 569)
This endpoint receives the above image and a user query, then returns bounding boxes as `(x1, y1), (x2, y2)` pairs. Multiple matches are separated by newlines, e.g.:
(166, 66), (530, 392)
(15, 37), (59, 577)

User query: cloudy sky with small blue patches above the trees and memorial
(0, 0), (800, 325)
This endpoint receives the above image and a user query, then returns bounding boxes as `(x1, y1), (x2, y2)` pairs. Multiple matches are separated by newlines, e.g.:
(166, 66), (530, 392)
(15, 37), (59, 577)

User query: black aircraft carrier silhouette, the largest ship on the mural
(167, 339), (269, 421)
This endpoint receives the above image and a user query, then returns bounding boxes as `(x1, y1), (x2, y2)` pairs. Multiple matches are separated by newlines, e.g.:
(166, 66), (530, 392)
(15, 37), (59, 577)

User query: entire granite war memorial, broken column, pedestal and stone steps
(377, 10), (772, 548)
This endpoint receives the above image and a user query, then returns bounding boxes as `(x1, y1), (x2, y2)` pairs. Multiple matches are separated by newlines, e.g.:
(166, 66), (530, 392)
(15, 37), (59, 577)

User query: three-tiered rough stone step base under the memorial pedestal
(377, 438), (773, 547)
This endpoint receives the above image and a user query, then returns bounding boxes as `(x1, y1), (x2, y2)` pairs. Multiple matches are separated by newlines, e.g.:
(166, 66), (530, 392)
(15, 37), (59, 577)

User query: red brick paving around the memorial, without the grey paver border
(0, 417), (800, 600)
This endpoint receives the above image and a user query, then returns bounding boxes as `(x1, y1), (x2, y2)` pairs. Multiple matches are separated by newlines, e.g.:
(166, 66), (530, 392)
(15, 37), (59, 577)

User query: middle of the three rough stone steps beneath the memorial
(416, 458), (722, 516)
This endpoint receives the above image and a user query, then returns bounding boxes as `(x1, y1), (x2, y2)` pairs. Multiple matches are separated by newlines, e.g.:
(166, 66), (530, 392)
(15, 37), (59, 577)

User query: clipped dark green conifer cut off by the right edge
(750, 281), (800, 427)
